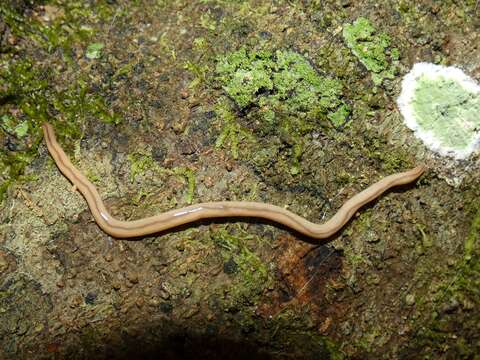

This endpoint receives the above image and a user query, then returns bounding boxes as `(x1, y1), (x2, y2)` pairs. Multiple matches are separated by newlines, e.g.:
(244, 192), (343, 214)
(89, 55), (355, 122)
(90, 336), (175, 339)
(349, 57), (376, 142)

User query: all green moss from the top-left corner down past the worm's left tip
(0, 0), (120, 198)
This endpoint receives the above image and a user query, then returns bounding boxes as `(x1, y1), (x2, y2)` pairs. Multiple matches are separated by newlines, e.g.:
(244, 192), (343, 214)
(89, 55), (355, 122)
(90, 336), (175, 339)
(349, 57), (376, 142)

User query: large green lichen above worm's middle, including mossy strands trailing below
(216, 47), (350, 175)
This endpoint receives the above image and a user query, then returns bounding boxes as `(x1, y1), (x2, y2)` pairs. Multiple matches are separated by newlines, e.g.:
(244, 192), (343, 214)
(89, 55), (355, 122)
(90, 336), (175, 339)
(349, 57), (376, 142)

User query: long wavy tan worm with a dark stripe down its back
(42, 123), (425, 239)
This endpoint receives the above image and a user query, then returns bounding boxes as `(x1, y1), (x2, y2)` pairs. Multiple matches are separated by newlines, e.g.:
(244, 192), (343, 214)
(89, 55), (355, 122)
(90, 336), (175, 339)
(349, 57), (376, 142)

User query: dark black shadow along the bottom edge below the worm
(44, 319), (338, 360)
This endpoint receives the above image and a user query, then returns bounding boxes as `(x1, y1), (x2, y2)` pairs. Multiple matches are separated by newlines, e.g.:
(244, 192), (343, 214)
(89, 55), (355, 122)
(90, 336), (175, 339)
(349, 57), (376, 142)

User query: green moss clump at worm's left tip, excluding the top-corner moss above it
(0, 59), (120, 198)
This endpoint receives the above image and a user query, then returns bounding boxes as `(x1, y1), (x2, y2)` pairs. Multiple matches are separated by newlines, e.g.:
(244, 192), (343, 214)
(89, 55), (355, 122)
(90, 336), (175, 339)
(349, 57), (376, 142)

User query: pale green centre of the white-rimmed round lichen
(412, 75), (480, 151)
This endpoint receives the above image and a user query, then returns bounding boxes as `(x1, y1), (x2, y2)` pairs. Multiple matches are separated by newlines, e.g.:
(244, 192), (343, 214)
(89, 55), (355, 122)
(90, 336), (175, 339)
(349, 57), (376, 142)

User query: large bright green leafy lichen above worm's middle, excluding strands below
(216, 48), (347, 122)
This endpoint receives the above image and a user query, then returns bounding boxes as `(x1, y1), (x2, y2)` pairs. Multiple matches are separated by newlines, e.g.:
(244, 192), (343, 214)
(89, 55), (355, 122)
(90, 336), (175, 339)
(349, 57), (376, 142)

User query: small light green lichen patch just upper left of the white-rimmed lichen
(343, 17), (400, 85)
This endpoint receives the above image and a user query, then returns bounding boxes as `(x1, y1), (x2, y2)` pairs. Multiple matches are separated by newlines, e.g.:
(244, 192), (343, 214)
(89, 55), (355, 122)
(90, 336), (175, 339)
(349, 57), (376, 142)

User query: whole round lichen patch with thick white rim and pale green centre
(397, 63), (480, 159)
